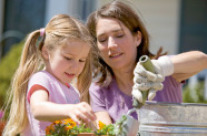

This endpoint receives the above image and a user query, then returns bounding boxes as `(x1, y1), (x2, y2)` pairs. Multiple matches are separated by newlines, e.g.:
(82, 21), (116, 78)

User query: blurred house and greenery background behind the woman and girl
(0, 0), (207, 115)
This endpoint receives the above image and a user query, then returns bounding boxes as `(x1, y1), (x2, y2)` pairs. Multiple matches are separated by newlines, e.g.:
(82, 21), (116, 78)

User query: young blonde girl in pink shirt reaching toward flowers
(3, 14), (96, 136)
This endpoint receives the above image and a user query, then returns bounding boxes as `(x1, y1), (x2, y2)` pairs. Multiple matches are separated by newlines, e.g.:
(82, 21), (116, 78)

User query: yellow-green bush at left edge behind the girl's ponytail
(0, 42), (23, 107)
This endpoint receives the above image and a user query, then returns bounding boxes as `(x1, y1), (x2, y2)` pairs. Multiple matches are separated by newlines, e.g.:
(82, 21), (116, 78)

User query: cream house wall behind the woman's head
(98, 0), (180, 54)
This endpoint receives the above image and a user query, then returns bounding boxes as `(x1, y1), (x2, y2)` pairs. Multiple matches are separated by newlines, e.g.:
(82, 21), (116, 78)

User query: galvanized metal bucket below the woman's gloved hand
(137, 102), (207, 136)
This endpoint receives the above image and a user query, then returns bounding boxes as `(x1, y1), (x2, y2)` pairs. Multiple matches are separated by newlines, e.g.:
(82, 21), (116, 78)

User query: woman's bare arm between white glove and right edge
(171, 51), (207, 82)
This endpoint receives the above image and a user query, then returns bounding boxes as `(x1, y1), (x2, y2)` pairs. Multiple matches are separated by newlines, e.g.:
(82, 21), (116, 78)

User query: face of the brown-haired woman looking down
(96, 18), (141, 70)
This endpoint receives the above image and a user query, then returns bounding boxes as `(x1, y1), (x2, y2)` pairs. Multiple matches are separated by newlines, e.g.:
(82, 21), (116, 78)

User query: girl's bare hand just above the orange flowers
(69, 102), (96, 124)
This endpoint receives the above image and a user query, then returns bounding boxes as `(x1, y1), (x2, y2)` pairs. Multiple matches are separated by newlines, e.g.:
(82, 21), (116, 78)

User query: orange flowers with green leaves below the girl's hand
(45, 116), (129, 136)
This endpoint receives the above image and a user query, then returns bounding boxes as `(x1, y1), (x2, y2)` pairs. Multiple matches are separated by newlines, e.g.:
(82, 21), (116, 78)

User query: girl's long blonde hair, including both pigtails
(3, 14), (94, 136)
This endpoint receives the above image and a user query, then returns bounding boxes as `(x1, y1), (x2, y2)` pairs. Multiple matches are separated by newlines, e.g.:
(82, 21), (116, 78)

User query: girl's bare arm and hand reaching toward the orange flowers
(30, 90), (96, 123)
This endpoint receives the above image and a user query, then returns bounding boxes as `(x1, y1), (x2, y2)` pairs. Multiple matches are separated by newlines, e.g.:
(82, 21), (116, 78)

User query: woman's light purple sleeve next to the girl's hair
(89, 83), (107, 112)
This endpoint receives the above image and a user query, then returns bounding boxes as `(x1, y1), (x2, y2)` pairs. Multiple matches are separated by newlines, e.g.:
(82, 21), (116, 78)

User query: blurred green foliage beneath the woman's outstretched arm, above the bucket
(183, 81), (207, 103)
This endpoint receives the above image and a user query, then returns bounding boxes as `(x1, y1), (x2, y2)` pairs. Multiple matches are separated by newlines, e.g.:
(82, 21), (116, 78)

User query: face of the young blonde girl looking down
(44, 40), (90, 84)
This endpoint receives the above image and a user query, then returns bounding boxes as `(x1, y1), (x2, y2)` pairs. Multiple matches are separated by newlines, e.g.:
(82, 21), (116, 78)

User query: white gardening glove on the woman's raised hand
(132, 56), (174, 103)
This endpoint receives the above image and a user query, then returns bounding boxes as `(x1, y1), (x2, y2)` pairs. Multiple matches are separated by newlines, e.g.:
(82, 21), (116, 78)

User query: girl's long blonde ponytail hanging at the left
(3, 30), (43, 136)
